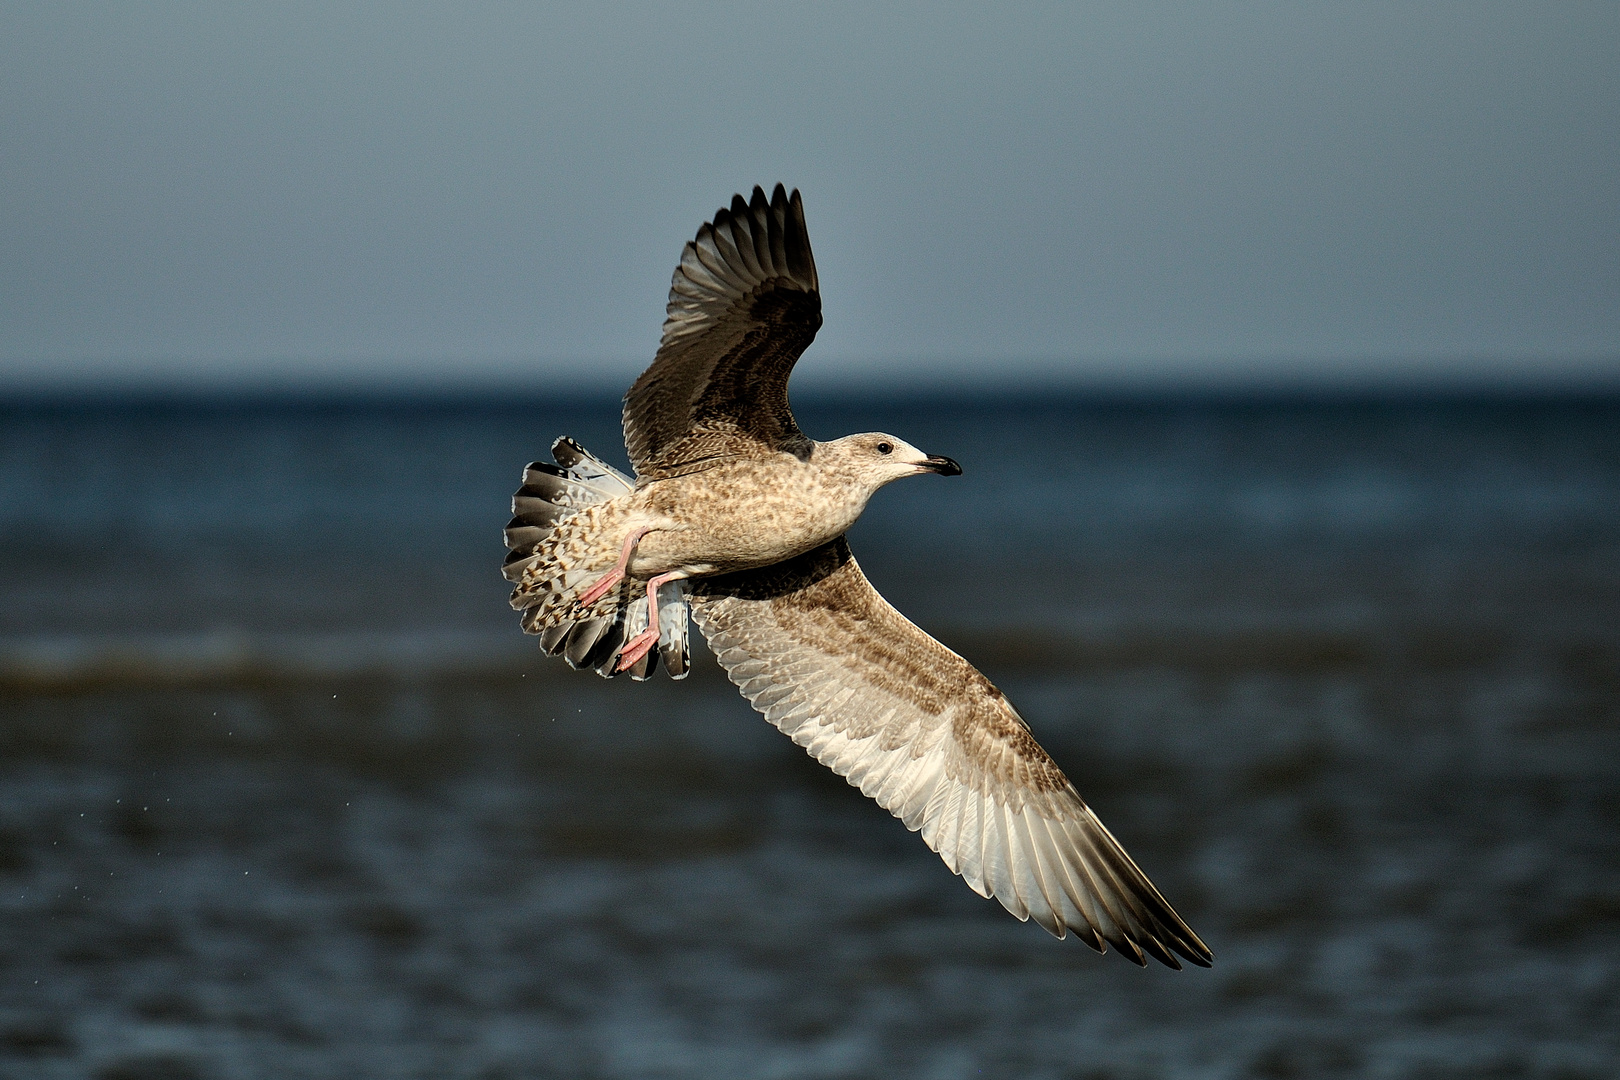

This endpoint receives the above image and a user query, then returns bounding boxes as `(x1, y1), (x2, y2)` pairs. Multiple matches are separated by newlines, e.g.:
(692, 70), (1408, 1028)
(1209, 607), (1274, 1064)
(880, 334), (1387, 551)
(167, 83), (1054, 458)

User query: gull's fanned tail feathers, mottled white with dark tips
(501, 437), (690, 682)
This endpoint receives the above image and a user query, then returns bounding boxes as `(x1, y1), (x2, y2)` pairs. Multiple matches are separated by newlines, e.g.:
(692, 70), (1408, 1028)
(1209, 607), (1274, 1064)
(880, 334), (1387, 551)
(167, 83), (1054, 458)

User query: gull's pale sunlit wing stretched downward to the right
(692, 538), (1212, 968)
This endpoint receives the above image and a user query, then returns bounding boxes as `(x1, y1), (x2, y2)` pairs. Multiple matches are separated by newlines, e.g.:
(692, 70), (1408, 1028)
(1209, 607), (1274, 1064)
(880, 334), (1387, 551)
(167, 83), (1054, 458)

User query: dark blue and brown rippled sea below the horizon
(0, 390), (1620, 1080)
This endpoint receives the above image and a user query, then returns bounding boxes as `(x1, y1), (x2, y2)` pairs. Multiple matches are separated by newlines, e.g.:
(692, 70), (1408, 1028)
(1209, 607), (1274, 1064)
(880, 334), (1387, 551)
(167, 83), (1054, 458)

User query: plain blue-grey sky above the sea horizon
(0, 0), (1620, 390)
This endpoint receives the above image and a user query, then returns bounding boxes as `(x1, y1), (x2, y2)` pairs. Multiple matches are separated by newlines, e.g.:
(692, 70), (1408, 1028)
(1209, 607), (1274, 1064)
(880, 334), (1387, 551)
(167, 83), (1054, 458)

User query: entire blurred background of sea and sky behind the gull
(0, 0), (1620, 1080)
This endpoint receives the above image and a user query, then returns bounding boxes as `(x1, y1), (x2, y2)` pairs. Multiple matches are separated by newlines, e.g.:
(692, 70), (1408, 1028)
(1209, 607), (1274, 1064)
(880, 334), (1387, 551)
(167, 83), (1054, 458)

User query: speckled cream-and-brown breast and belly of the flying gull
(630, 453), (870, 578)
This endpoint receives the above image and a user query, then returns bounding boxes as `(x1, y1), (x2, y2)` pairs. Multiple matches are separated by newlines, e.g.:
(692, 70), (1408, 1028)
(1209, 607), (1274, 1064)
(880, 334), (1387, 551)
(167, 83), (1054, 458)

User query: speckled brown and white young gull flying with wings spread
(504, 185), (1212, 970)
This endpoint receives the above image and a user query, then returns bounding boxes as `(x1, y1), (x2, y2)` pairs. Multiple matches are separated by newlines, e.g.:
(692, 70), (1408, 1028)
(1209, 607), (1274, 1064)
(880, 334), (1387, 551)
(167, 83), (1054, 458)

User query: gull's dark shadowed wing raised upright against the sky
(624, 185), (821, 479)
